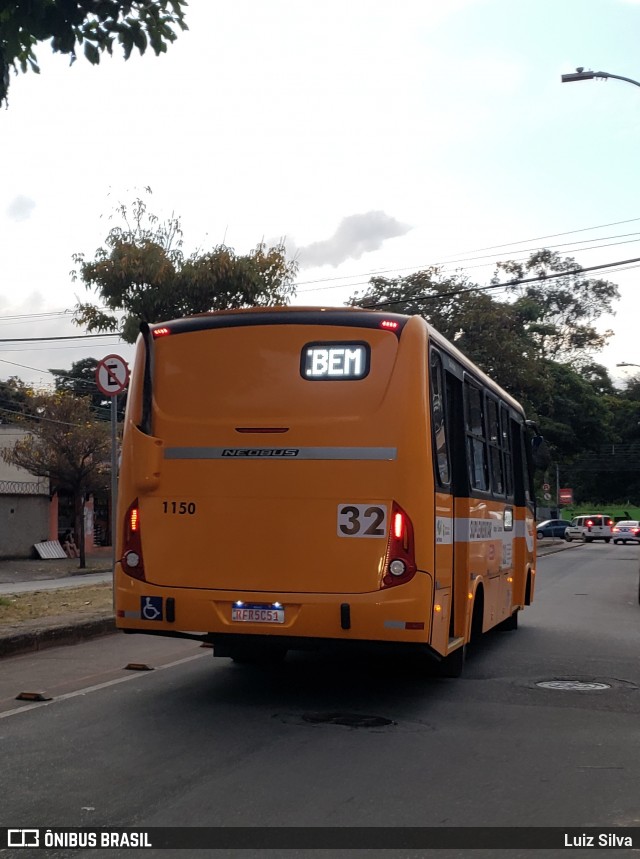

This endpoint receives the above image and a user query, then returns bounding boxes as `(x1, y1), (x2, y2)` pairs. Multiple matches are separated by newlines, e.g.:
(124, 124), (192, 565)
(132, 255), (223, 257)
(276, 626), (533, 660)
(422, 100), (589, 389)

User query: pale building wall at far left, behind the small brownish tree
(0, 424), (51, 558)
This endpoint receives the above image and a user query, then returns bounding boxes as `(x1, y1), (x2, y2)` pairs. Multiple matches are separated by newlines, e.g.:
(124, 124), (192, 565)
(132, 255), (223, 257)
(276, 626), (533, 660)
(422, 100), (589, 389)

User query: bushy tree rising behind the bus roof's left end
(72, 195), (298, 343)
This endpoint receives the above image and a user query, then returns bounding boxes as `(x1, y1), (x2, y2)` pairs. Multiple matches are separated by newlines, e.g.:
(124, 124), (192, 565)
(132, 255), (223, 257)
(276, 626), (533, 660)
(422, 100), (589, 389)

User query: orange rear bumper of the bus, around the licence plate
(115, 565), (433, 647)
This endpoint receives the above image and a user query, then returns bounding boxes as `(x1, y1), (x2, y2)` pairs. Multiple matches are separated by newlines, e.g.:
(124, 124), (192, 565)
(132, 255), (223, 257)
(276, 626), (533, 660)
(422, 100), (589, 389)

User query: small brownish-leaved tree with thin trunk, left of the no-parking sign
(2, 393), (111, 567)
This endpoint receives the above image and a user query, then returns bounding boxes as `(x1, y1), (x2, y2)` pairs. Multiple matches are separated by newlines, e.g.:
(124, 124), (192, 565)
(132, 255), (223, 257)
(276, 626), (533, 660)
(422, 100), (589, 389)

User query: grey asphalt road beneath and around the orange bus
(0, 544), (640, 859)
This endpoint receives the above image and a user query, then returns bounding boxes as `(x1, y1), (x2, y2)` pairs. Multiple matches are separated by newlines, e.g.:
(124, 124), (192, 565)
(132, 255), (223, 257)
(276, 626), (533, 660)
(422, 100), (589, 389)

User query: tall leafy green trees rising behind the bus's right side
(350, 250), (624, 498)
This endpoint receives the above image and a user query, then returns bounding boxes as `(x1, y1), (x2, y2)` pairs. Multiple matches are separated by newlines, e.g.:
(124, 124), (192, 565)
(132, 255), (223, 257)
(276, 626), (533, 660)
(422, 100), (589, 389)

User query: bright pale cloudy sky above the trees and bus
(0, 0), (640, 394)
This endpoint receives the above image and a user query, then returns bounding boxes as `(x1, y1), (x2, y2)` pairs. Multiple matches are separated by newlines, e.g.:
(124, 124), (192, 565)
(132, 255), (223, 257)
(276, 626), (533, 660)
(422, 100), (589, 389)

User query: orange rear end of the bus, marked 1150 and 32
(115, 309), (434, 655)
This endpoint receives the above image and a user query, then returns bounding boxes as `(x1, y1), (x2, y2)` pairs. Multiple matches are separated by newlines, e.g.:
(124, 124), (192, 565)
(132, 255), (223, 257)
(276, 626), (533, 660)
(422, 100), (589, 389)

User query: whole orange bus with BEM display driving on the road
(114, 307), (536, 676)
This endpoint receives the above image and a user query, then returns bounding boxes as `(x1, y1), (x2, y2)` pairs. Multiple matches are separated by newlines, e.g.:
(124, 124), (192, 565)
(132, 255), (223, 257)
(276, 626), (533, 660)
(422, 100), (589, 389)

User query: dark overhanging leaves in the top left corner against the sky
(0, 0), (187, 104)
